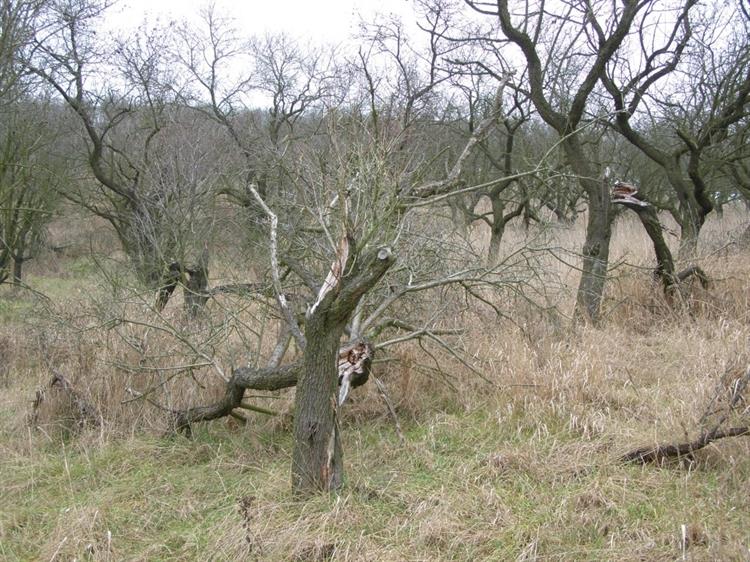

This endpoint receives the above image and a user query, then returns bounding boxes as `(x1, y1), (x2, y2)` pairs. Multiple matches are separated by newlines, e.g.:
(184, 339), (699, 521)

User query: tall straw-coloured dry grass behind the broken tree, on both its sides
(8, 203), (750, 440)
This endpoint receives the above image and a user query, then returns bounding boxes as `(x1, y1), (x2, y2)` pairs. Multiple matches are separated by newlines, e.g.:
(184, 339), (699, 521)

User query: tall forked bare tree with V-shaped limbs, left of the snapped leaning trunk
(431, 0), (704, 321)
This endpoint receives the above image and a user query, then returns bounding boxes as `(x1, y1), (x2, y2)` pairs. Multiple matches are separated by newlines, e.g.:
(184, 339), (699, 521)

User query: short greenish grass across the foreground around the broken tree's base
(0, 392), (750, 560)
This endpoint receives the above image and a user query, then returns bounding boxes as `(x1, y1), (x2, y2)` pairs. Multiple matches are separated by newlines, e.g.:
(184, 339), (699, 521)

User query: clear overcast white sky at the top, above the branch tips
(109, 0), (414, 43)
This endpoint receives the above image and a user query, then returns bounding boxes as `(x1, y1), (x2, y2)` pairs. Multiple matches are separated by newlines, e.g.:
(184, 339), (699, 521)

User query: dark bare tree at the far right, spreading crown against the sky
(603, 2), (750, 257)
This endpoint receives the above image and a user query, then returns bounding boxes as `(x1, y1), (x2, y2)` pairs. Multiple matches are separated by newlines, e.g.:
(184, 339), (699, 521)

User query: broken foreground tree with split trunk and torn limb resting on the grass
(157, 7), (552, 492)
